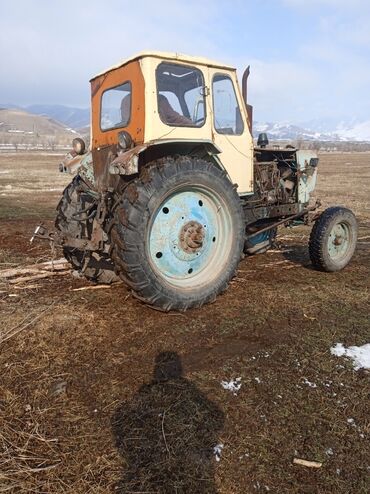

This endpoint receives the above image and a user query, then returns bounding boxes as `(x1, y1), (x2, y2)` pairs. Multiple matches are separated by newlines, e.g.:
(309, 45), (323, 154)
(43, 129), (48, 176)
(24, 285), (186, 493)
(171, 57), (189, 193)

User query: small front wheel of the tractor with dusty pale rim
(309, 206), (358, 272)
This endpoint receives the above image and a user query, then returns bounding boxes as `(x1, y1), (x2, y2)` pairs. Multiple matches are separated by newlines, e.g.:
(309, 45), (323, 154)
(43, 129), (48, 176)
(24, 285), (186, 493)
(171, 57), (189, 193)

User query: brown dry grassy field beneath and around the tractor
(0, 153), (370, 494)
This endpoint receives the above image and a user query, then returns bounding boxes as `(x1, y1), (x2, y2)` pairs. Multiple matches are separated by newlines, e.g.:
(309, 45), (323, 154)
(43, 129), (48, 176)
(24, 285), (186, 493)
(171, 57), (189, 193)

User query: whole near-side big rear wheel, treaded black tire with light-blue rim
(110, 157), (244, 311)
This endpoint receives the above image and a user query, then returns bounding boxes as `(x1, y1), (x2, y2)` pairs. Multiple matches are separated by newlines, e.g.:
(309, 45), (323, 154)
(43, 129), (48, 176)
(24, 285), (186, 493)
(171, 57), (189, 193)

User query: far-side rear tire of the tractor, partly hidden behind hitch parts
(55, 175), (120, 284)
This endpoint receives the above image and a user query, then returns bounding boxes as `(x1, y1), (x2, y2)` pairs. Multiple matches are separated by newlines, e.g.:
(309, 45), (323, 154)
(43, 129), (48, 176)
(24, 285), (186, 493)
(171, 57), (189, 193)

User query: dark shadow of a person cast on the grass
(112, 352), (224, 494)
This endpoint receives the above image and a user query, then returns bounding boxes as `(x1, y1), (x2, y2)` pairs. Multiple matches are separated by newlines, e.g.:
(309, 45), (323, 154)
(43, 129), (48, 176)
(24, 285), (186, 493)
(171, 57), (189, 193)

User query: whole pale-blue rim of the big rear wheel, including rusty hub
(147, 185), (233, 289)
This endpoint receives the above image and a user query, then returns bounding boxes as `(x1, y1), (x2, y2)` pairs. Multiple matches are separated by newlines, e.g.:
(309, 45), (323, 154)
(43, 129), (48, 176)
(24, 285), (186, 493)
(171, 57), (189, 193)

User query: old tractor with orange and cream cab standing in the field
(36, 52), (357, 311)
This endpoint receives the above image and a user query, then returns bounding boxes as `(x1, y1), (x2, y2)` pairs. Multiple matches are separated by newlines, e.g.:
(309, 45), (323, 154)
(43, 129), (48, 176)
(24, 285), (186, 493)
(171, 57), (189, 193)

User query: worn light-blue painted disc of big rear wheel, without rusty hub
(149, 187), (227, 286)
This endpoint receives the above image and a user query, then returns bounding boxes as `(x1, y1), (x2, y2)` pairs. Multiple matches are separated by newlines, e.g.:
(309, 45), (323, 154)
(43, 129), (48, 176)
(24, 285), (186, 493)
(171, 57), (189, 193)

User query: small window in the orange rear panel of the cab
(100, 82), (131, 130)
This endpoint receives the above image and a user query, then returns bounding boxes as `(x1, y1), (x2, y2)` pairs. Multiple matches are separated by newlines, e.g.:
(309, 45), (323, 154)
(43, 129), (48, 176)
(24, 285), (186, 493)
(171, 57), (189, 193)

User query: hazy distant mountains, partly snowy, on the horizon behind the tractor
(0, 104), (370, 142)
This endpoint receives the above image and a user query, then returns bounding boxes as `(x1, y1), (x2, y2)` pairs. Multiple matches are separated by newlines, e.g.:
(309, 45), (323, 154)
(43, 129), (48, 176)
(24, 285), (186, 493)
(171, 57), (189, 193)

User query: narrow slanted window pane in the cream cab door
(212, 74), (244, 135)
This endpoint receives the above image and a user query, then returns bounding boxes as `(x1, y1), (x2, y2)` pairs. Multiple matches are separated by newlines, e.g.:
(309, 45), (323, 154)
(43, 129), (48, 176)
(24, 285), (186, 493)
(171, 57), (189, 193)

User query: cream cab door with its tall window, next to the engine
(209, 68), (253, 195)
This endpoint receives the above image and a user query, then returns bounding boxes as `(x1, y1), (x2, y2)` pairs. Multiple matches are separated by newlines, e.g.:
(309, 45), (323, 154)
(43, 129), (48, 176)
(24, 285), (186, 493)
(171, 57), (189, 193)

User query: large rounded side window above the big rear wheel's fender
(156, 63), (206, 127)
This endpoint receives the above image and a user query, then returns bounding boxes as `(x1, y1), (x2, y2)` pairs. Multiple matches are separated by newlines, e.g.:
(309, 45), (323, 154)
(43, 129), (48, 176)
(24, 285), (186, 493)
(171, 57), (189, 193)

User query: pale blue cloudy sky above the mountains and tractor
(0, 0), (370, 122)
